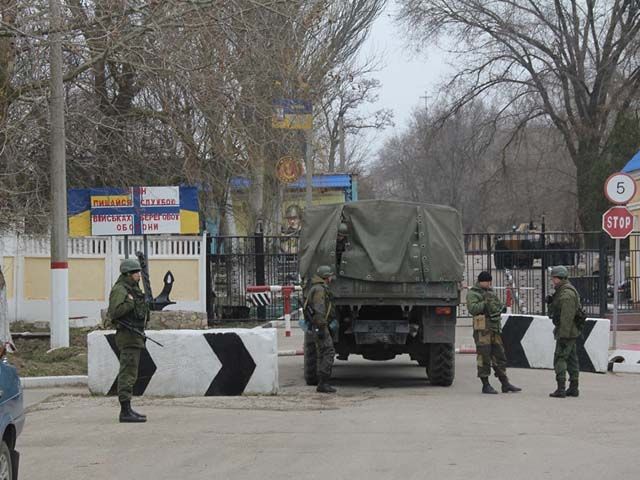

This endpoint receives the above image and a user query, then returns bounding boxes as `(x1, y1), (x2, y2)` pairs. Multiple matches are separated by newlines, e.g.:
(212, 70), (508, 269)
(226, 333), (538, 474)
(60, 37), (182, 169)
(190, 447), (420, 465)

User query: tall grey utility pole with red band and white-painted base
(49, 0), (69, 349)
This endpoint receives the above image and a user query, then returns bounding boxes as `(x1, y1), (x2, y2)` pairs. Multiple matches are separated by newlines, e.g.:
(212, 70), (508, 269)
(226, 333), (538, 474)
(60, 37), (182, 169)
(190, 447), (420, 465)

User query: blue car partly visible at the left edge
(0, 345), (24, 480)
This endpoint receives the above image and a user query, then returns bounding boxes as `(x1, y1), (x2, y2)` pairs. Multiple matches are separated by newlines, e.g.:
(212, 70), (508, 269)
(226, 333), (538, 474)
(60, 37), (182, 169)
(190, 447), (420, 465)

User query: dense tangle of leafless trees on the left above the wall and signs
(0, 0), (384, 236)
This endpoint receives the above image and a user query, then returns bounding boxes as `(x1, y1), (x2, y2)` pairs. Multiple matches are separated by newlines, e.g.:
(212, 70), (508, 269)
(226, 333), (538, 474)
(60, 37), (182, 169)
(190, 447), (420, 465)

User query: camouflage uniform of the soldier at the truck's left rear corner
(307, 275), (336, 381)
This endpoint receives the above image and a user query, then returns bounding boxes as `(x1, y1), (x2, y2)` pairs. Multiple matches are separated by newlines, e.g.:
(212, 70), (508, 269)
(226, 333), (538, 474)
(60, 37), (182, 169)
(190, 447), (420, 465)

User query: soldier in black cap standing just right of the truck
(467, 272), (522, 394)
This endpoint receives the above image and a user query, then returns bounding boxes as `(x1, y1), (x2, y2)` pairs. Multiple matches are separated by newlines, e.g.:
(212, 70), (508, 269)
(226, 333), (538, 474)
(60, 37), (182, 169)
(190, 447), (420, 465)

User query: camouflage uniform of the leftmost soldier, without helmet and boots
(109, 274), (148, 402)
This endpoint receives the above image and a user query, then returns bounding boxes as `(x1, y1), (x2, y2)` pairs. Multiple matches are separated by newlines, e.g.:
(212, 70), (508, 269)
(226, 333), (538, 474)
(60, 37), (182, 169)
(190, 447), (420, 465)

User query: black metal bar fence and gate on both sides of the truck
(207, 231), (640, 321)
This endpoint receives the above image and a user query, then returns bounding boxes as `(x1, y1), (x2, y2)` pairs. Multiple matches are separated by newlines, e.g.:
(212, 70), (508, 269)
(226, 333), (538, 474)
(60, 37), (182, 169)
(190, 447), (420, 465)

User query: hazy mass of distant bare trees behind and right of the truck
(368, 101), (576, 231)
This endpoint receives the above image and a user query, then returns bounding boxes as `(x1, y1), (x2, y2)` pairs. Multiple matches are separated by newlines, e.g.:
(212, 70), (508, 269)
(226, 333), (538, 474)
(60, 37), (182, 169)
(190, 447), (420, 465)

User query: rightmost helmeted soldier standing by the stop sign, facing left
(547, 266), (580, 398)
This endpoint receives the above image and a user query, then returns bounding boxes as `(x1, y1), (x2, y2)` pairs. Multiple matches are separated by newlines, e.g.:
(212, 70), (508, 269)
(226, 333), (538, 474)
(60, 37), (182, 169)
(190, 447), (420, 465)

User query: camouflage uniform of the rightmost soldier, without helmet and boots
(549, 279), (580, 383)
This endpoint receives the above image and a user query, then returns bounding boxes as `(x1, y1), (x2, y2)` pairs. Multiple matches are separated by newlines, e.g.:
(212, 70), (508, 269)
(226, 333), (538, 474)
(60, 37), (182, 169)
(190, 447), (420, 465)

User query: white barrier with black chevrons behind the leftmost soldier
(87, 328), (278, 397)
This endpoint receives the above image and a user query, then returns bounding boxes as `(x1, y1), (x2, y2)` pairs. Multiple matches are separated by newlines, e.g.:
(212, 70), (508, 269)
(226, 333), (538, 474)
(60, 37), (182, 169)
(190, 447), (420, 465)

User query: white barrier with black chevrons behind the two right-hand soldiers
(502, 315), (610, 373)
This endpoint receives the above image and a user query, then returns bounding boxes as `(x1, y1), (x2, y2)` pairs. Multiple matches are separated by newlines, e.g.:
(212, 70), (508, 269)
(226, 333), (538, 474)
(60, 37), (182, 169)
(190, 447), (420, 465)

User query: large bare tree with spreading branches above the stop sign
(400, 0), (640, 228)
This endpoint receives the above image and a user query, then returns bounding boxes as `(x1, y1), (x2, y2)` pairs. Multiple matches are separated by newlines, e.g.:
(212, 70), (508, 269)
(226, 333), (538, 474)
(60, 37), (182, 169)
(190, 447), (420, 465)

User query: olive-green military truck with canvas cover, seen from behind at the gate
(299, 200), (464, 386)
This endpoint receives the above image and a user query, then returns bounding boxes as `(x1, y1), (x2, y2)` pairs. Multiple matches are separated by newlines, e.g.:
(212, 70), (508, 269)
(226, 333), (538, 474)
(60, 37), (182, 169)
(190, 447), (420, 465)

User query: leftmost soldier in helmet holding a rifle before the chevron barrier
(109, 259), (148, 423)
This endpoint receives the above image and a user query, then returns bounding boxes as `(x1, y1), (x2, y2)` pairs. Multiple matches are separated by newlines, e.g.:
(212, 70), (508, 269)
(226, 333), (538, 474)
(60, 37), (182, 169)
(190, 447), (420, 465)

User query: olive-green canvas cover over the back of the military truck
(300, 200), (464, 283)
